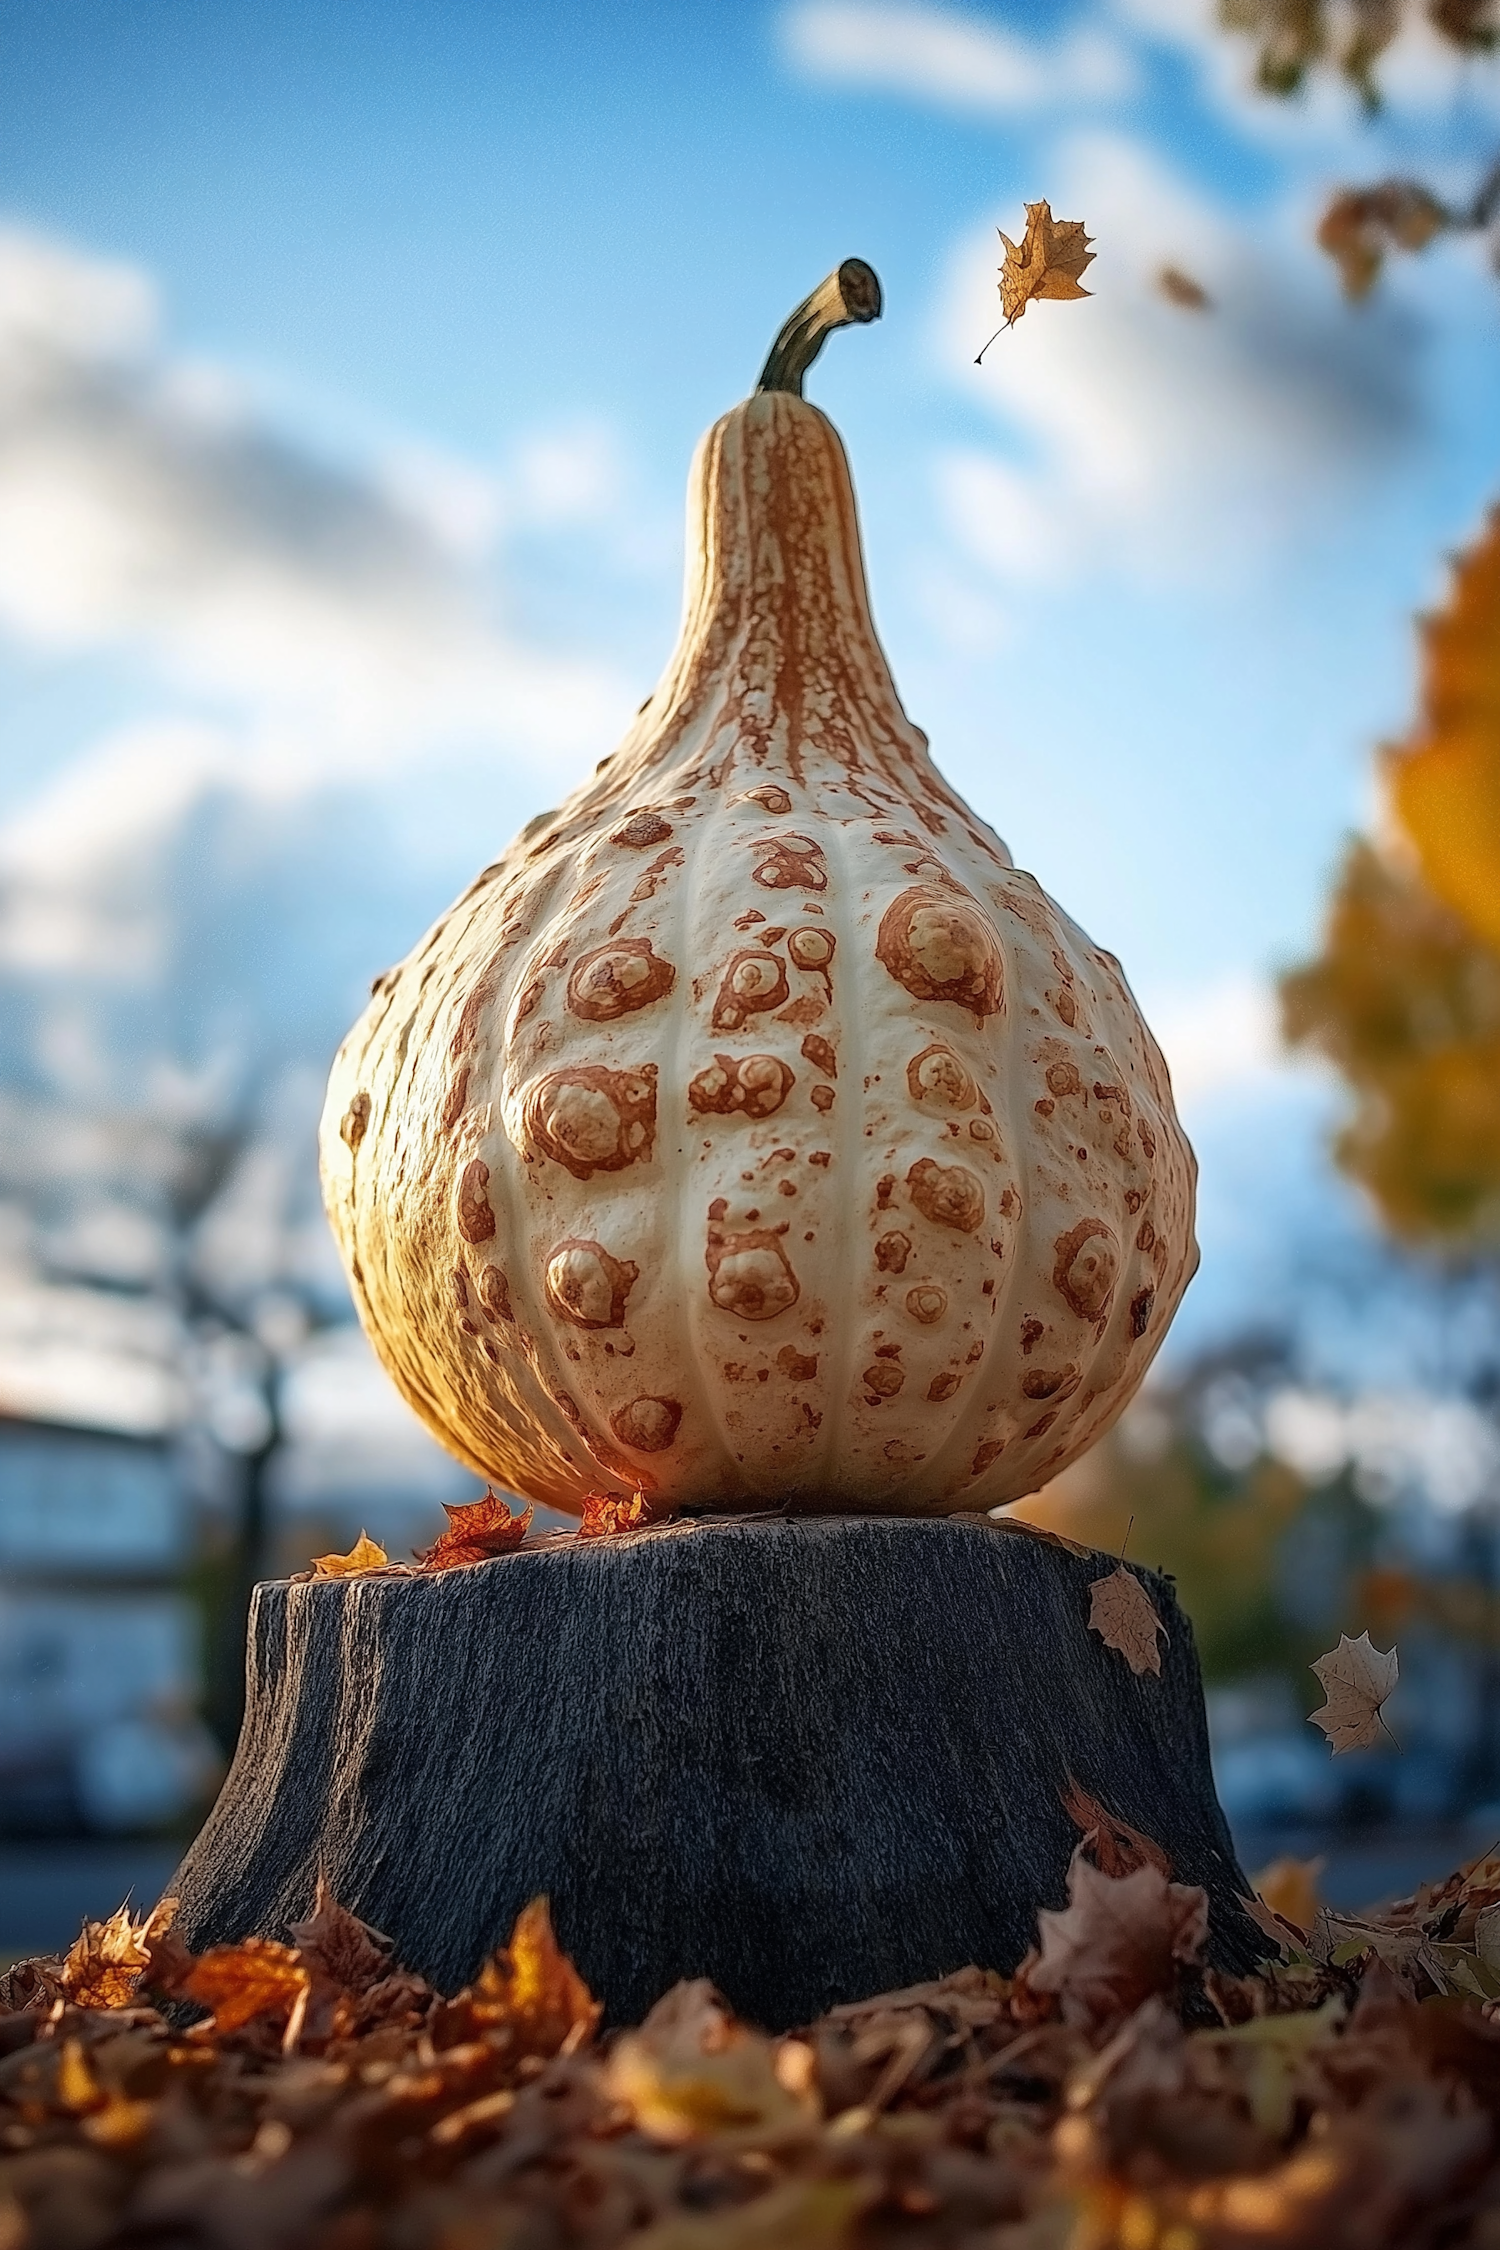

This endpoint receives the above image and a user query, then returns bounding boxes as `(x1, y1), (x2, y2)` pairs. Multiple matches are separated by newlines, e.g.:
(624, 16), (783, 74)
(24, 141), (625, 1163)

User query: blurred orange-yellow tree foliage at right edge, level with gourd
(1282, 511), (1500, 1249)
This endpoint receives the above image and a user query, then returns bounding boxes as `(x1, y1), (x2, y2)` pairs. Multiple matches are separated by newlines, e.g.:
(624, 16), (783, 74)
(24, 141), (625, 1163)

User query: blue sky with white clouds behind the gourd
(0, 0), (1500, 1368)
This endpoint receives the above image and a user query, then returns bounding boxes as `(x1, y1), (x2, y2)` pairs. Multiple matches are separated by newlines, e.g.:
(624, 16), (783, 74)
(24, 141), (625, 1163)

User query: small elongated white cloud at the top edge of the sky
(780, 0), (1133, 117)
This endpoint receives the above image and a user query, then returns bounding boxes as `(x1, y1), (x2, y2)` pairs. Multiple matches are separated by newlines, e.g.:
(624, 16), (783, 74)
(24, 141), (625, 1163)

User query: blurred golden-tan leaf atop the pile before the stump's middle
(605, 1978), (819, 2144)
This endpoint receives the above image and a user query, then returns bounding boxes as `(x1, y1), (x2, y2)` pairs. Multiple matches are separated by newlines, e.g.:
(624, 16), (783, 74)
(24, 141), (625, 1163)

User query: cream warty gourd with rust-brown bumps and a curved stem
(322, 259), (1196, 1514)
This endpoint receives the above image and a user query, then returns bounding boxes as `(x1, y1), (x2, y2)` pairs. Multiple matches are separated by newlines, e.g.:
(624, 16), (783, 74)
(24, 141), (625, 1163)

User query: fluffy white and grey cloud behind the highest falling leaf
(938, 135), (1421, 581)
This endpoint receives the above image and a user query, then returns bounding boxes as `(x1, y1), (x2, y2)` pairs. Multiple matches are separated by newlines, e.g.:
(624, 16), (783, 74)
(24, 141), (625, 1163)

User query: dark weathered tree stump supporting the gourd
(173, 1517), (1266, 2030)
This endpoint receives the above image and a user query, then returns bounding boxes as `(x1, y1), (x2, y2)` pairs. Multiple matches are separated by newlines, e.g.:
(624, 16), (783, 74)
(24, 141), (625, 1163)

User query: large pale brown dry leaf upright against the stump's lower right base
(1023, 1847), (1208, 2025)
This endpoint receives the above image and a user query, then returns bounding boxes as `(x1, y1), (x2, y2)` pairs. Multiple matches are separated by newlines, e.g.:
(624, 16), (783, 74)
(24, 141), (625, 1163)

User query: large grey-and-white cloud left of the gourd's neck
(0, 230), (627, 774)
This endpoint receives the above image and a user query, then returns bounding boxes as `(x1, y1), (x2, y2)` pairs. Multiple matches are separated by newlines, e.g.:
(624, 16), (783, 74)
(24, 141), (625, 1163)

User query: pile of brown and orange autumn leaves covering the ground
(0, 1845), (1500, 2250)
